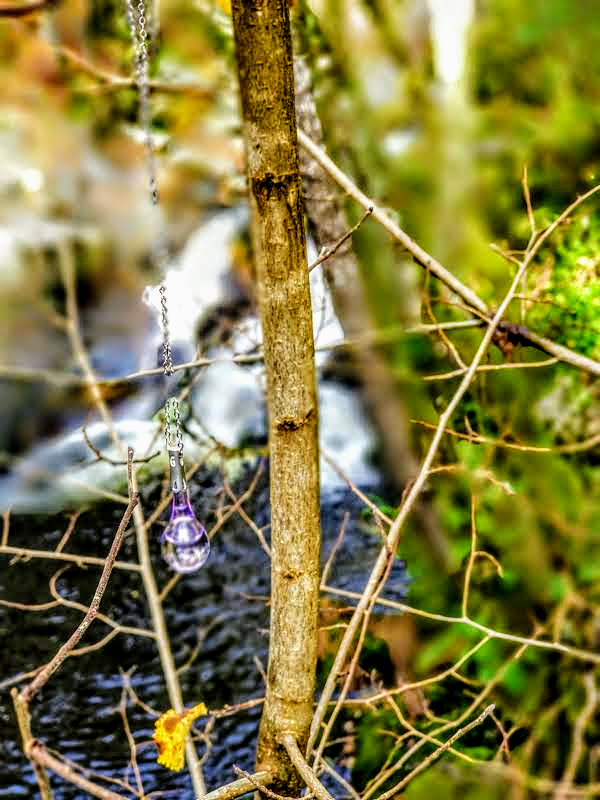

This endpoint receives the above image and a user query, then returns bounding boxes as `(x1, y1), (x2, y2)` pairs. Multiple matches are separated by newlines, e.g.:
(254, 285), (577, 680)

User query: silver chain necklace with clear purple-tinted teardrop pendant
(126, 0), (210, 572)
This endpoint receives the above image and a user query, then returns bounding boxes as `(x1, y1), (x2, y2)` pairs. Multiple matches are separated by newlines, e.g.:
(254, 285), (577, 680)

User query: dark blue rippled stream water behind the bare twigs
(0, 474), (404, 800)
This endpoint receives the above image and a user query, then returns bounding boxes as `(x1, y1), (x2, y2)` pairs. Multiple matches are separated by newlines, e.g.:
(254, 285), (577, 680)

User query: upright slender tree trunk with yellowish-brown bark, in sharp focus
(232, 0), (320, 795)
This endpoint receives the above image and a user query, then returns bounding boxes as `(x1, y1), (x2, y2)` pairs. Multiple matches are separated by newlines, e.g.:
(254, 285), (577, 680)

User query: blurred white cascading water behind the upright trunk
(0, 208), (378, 512)
